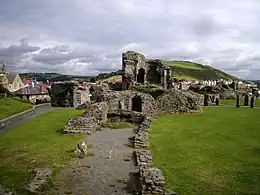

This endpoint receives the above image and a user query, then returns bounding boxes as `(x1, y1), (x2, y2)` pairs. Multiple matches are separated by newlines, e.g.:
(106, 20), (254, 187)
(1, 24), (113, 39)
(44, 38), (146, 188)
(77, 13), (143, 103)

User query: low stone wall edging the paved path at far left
(0, 103), (51, 129)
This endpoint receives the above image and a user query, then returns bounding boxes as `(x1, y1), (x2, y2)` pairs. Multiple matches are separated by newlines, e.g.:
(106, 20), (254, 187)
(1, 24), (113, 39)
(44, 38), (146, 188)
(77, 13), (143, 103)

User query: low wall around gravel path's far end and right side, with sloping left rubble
(64, 102), (169, 195)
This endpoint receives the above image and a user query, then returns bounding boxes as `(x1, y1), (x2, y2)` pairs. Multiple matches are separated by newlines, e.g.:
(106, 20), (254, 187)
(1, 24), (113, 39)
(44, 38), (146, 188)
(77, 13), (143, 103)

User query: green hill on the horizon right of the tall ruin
(166, 61), (240, 80)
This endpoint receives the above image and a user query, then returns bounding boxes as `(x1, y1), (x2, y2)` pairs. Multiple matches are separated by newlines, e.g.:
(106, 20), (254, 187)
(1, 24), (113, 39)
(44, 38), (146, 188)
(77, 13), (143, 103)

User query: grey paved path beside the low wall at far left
(0, 107), (56, 136)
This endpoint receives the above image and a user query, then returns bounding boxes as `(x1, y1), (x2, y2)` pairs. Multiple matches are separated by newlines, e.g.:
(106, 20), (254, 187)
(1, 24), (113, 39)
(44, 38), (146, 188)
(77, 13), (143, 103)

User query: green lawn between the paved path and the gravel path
(0, 108), (84, 191)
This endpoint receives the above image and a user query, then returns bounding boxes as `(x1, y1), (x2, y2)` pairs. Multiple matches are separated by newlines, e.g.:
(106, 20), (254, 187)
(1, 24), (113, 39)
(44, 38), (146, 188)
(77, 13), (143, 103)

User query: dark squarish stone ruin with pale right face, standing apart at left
(50, 82), (90, 107)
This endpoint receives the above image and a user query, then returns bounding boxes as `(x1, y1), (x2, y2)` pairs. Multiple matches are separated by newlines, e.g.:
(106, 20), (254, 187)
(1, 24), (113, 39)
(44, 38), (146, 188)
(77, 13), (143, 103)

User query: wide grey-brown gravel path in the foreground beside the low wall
(52, 129), (138, 195)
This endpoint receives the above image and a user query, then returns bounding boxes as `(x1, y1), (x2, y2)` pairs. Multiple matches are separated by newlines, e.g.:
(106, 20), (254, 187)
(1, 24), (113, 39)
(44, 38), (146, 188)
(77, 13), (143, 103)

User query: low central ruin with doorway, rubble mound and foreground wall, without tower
(64, 89), (202, 195)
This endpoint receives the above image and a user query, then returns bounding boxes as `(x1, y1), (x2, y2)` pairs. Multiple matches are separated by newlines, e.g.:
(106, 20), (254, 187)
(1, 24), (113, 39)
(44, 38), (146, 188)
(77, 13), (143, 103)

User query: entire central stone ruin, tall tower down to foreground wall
(63, 52), (203, 194)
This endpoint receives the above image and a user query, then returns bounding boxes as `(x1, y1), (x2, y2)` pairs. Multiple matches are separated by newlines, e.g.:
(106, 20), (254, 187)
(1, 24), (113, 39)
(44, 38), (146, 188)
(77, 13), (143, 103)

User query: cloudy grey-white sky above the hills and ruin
(0, 0), (260, 79)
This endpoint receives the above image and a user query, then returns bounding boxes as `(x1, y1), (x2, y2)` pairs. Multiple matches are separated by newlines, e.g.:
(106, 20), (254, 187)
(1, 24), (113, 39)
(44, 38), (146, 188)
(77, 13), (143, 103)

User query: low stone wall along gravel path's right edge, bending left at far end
(108, 110), (165, 195)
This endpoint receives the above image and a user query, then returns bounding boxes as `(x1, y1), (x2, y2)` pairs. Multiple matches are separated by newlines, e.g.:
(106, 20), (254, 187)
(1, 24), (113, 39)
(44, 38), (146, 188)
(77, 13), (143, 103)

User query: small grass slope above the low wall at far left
(0, 98), (32, 119)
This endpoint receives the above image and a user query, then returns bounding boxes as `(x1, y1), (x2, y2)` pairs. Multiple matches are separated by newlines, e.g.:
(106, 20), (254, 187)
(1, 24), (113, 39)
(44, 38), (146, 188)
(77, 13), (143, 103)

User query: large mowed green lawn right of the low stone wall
(149, 107), (260, 195)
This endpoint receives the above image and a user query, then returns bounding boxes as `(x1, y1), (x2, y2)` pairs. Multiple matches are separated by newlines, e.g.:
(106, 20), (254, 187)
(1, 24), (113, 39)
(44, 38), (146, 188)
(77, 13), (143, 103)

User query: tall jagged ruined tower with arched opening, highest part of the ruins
(122, 51), (172, 90)
